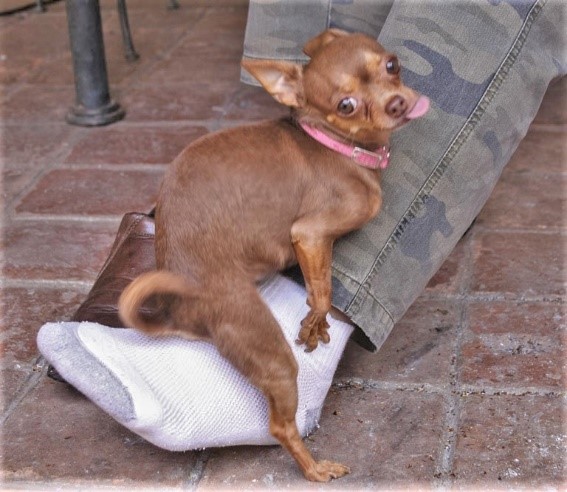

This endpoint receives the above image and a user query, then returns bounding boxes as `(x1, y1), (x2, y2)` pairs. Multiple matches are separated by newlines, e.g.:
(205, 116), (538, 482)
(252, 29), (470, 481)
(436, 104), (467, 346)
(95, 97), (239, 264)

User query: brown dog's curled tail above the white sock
(118, 270), (196, 334)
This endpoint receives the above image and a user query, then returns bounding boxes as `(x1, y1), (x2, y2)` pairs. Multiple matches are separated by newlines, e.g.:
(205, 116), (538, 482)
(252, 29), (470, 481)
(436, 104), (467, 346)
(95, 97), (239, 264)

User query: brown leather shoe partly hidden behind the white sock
(47, 213), (156, 381)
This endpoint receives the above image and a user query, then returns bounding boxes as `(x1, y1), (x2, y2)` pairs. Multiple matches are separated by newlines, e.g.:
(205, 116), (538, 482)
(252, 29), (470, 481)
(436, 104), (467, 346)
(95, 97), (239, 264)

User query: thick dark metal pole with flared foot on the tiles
(66, 0), (125, 126)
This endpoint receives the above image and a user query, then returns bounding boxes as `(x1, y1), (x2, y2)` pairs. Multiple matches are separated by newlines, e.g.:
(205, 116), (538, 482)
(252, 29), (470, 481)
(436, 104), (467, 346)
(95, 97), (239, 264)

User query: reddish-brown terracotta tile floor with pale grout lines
(0, 0), (567, 490)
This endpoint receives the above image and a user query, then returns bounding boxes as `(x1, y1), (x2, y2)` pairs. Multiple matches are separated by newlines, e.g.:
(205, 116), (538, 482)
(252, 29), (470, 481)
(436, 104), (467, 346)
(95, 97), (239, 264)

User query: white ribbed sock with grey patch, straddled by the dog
(38, 275), (352, 451)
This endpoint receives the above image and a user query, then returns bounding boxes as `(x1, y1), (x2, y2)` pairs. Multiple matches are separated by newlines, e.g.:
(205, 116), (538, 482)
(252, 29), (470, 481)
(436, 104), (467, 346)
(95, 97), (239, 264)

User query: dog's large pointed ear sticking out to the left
(242, 60), (304, 108)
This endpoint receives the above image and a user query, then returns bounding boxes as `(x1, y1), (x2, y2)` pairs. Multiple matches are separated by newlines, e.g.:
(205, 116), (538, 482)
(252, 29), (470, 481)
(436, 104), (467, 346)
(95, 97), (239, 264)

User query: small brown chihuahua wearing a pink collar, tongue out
(119, 29), (429, 481)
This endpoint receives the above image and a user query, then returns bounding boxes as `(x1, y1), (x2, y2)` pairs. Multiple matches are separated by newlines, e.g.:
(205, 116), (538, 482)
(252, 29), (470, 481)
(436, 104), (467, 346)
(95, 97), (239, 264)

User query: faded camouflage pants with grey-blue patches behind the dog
(243, 0), (567, 348)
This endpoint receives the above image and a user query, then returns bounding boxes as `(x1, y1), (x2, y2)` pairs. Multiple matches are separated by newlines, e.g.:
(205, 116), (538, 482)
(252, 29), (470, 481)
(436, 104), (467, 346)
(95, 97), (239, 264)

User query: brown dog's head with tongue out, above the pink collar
(242, 29), (429, 145)
